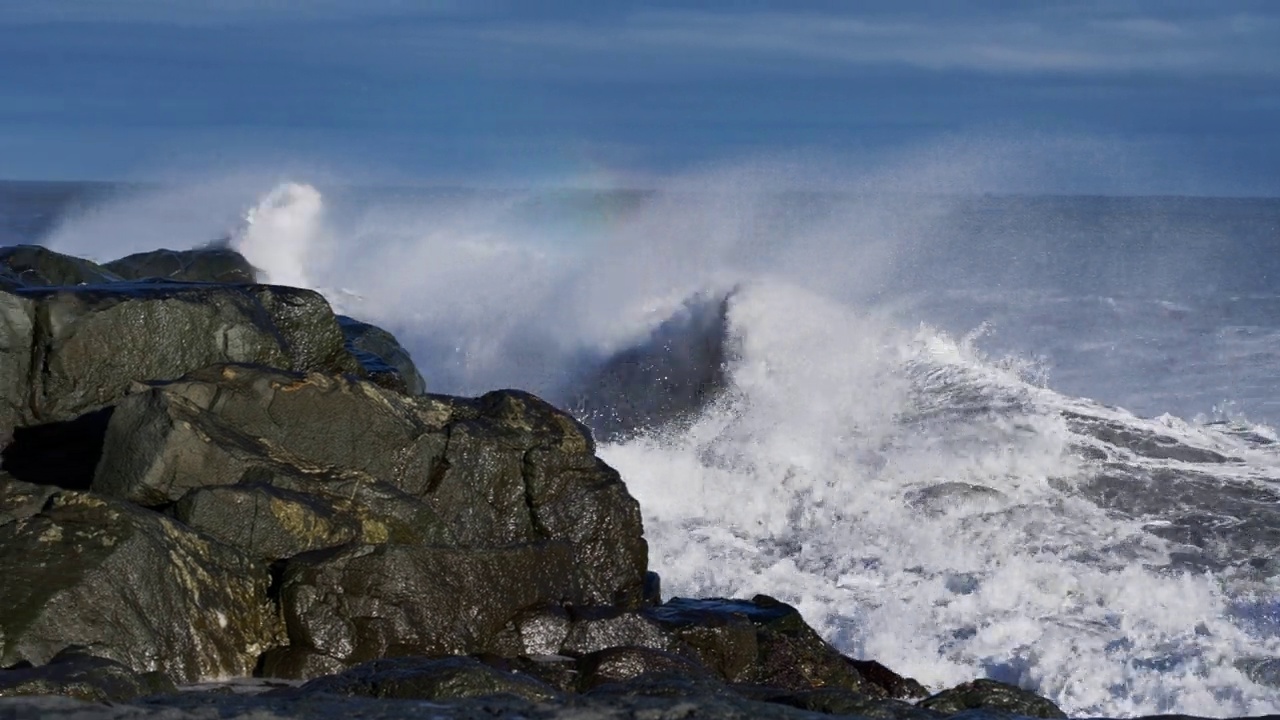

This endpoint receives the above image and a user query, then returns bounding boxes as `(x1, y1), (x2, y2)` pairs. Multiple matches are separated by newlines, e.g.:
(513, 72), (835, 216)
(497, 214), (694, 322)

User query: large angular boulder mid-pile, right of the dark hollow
(93, 366), (648, 607)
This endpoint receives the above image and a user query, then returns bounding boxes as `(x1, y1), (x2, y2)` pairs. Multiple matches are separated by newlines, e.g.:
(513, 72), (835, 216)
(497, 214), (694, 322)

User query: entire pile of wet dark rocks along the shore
(0, 246), (1080, 719)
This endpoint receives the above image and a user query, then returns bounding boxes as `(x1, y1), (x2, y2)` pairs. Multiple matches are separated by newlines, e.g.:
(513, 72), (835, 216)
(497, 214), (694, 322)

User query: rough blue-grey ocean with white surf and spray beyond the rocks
(0, 173), (1280, 716)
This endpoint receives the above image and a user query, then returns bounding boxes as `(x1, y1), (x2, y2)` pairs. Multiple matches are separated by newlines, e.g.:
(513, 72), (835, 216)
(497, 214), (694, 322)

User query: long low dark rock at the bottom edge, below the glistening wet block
(296, 657), (561, 702)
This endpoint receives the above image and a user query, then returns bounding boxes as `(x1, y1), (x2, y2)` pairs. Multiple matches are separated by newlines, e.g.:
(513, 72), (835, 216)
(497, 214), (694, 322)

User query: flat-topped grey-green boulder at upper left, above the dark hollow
(0, 283), (360, 427)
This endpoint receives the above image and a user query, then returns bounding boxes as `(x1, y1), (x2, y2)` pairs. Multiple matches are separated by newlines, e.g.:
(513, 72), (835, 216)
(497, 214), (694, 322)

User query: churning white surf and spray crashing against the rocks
(45, 174), (1280, 716)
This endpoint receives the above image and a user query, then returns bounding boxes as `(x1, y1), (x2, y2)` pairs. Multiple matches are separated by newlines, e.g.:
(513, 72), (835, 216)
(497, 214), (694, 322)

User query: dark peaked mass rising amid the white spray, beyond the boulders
(558, 288), (732, 442)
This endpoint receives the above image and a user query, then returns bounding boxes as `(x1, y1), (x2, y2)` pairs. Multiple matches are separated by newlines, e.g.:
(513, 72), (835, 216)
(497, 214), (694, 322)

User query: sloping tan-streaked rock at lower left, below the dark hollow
(0, 487), (283, 682)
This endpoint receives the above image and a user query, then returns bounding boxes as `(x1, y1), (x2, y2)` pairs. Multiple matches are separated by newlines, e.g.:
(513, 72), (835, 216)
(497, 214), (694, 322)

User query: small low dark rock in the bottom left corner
(0, 647), (178, 702)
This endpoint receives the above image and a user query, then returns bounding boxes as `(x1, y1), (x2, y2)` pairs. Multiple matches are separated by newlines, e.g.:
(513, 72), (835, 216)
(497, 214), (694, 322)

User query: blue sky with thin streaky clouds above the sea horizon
(0, 0), (1280, 195)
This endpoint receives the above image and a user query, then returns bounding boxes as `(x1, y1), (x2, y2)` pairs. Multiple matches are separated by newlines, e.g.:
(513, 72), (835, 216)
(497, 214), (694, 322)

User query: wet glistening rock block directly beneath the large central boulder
(270, 543), (576, 670)
